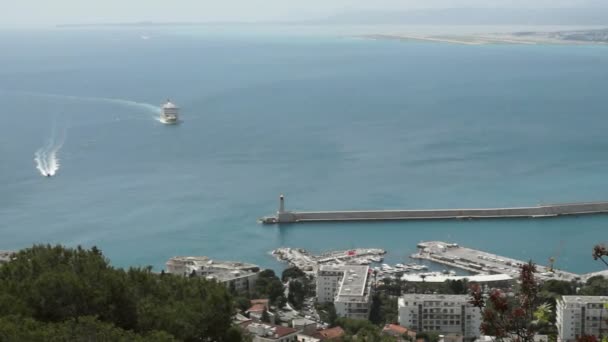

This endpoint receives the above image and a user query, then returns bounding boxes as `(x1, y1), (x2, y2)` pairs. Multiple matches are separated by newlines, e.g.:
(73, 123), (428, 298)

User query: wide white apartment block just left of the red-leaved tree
(399, 294), (481, 340)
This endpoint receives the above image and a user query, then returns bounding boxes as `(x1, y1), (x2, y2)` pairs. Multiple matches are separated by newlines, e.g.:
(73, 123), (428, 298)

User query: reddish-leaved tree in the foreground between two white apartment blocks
(470, 262), (551, 342)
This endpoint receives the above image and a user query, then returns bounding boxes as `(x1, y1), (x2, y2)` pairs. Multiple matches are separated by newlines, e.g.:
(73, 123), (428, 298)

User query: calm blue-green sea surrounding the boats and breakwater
(0, 27), (608, 272)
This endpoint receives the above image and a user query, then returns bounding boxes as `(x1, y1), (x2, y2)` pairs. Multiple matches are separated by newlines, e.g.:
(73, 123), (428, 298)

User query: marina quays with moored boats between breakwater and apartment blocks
(271, 241), (608, 285)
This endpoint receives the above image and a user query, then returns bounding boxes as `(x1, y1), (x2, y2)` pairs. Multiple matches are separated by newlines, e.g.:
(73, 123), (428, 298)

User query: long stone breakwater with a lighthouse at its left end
(260, 195), (608, 224)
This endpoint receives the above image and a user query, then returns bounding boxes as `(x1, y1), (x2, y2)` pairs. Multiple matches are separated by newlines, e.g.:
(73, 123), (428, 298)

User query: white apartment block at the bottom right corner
(555, 296), (608, 342)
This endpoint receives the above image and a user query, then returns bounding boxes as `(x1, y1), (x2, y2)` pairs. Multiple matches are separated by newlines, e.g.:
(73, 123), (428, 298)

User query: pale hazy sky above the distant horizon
(0, 0), (608, 27)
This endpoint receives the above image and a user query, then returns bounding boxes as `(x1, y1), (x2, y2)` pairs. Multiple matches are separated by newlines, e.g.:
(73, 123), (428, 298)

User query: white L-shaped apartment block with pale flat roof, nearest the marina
(317, 265), (372, 319)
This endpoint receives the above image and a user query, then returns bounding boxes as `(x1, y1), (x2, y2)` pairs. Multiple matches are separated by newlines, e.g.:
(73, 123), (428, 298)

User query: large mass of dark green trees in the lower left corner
(0, 245), (247, 341)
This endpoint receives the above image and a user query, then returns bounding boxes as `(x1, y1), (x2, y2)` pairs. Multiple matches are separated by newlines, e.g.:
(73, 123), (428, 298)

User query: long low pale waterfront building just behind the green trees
(166, 256), (260, 292)
